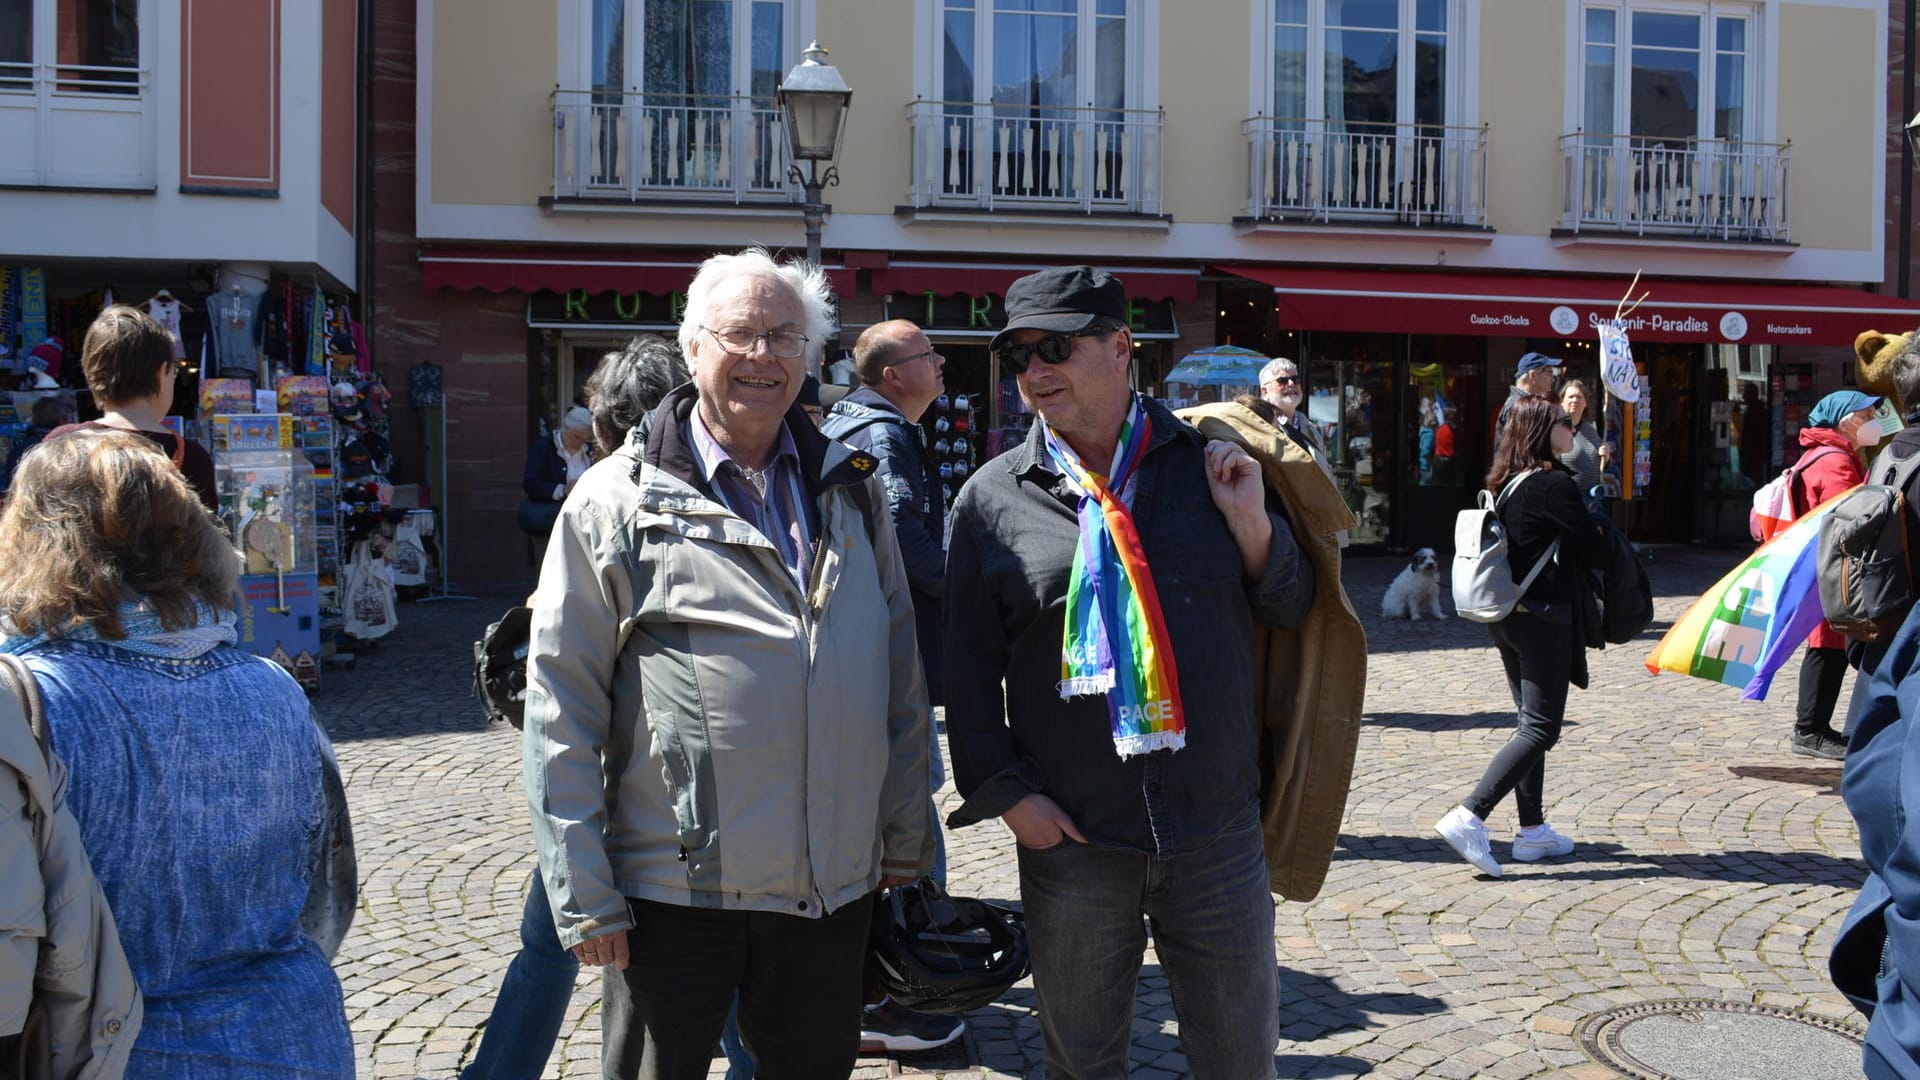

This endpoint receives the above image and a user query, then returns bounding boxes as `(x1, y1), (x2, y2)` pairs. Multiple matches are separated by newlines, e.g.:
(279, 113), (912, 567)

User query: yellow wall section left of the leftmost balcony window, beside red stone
(432, 0), (559, 206)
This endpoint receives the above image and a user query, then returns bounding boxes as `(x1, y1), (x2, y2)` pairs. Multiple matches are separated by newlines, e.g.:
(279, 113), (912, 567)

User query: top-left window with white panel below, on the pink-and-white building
(0, 0), (156, 188)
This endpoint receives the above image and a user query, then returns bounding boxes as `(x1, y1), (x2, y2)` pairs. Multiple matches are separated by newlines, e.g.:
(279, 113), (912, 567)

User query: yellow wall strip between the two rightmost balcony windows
(1469, 0), (1567, 236)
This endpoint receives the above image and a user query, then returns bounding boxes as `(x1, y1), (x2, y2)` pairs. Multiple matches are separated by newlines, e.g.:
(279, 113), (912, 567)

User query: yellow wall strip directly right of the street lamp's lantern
(817, 0), (916, 213)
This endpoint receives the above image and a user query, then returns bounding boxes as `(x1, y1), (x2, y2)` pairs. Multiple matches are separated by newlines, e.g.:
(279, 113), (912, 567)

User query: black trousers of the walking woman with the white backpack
(1463, 611), (1572, 828)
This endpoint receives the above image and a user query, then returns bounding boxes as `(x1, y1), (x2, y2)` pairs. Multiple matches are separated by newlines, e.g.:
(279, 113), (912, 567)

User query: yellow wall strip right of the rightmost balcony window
(1778, 4), (1882, 252)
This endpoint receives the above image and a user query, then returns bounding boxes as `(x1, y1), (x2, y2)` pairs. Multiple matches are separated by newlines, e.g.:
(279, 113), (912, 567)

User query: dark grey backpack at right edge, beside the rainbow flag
(1814, 445), (1920, 642)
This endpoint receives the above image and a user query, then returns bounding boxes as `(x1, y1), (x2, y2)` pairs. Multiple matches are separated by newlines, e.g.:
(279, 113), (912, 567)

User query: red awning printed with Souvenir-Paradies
(1219, 267), (1920, 346)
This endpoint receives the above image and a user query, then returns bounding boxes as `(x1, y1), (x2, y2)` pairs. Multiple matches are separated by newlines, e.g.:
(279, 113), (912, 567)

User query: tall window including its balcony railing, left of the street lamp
(555, 0), (799, 198)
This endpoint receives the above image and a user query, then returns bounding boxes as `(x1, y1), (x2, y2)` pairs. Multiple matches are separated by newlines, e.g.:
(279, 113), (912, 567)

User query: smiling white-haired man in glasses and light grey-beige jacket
(522, 248), (933, 1080)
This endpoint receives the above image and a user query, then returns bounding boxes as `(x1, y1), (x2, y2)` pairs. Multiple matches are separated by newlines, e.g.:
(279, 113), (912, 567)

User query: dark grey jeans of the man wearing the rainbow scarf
(1020, 805), (1281, 1080)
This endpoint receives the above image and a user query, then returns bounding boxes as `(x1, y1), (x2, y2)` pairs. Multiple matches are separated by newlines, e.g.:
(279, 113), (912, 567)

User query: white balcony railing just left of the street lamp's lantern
(553, 90), (795, 204)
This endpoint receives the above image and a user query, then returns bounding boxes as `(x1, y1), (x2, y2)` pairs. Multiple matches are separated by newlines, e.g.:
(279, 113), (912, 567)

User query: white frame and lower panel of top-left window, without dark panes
(0, 0), (161, 190)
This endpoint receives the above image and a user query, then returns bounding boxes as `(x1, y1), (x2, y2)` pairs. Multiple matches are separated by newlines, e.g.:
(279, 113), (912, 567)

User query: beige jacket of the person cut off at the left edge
(0, 678), (142, 1080)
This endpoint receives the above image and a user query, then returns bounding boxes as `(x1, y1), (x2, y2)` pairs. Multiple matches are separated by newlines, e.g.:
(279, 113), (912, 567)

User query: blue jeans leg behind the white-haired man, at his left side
(461, 867), (580, 1080)
